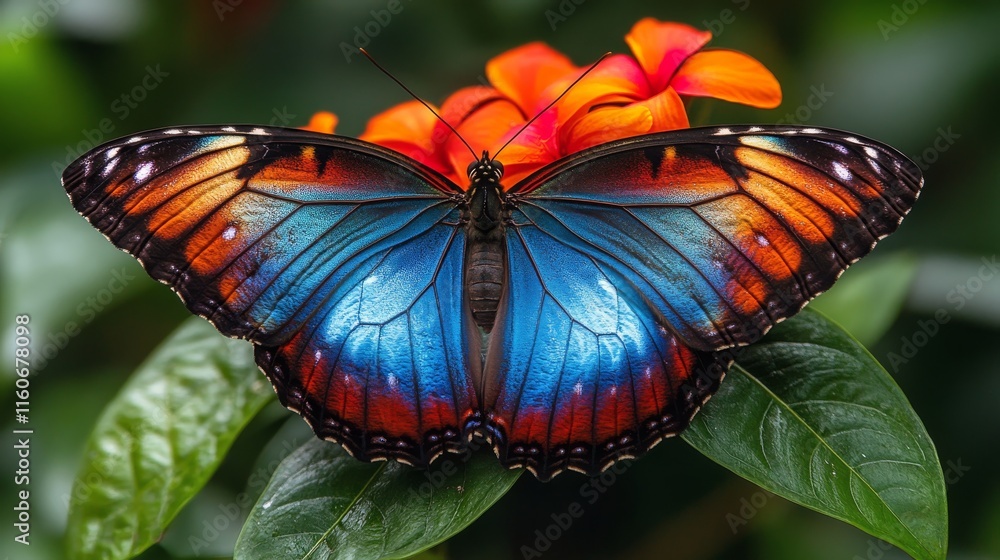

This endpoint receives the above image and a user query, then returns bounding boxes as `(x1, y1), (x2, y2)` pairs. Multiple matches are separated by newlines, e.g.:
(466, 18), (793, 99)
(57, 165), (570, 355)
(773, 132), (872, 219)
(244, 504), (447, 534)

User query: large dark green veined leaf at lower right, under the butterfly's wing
(683, 310), (948, 560)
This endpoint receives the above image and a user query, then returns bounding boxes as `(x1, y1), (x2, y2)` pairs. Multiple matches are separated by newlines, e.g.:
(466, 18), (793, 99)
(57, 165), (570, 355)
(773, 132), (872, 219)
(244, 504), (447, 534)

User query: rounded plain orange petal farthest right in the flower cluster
(670, 49), (781, 109)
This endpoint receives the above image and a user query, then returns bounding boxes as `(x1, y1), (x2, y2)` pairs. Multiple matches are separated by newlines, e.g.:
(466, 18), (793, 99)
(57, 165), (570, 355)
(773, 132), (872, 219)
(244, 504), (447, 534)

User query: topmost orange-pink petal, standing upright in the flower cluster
(625, 18), (712, 91)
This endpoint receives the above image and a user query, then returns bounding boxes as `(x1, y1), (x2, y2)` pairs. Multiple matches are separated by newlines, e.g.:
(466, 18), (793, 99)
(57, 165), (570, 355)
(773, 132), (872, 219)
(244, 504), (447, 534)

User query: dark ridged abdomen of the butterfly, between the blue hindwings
(465, 235), (505, 332)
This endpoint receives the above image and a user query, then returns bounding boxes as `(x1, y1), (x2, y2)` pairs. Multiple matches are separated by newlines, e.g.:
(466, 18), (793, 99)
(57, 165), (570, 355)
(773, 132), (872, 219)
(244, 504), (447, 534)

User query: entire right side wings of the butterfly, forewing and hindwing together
(483, 127), (922, 478)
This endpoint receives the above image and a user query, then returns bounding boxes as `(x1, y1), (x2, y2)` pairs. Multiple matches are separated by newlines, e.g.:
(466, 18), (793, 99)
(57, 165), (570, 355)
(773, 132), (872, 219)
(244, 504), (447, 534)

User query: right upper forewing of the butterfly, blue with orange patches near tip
(511, 127), (922, 350)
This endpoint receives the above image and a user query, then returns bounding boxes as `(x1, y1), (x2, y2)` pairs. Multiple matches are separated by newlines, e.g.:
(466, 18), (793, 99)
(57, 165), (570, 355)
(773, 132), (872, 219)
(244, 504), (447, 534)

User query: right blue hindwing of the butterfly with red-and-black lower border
(484, 217), (728, 480)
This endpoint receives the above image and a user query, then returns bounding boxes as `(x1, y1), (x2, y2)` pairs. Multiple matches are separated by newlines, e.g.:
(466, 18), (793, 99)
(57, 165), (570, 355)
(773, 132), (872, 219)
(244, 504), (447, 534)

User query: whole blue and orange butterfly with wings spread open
(63, 121), (923, 480)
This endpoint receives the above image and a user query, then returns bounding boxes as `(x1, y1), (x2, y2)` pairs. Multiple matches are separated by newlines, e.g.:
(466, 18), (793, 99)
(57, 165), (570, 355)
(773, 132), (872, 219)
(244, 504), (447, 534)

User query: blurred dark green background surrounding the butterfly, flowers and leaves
(0, 0), (1000, 559)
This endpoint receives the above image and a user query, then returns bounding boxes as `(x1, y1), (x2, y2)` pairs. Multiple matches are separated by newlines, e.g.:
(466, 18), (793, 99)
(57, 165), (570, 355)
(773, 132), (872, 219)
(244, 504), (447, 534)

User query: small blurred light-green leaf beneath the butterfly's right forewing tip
(810, 253), (919, 345)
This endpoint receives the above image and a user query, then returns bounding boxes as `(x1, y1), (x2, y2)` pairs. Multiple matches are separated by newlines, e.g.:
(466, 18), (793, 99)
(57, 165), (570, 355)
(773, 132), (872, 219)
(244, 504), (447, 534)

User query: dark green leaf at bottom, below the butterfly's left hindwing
(235, 440), (522, 560)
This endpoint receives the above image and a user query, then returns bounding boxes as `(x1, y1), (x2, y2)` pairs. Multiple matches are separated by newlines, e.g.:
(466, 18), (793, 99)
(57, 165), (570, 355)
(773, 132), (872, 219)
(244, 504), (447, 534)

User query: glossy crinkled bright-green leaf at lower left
(67, 317), (274, 560)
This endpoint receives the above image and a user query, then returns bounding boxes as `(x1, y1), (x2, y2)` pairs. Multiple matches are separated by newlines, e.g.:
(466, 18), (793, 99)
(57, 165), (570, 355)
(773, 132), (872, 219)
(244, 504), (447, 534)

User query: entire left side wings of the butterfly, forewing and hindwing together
(63, 127), (480, 464)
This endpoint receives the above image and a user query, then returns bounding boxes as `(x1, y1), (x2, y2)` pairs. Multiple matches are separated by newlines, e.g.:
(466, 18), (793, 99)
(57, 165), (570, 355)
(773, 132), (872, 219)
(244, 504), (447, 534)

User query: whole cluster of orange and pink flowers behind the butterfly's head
(307, 18), (781, 186)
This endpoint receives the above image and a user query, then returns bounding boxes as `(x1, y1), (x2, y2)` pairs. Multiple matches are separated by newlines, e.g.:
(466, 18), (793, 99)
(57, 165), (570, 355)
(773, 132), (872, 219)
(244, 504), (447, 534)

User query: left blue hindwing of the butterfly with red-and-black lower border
(256, 217), (479, 464)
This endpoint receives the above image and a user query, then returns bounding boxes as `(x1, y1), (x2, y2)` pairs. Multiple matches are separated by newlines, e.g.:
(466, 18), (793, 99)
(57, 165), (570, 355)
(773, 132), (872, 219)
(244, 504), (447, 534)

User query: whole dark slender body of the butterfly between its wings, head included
(463, 152), (509, 331)
